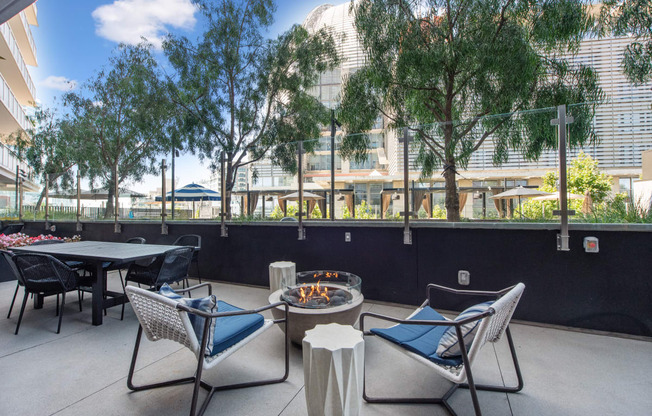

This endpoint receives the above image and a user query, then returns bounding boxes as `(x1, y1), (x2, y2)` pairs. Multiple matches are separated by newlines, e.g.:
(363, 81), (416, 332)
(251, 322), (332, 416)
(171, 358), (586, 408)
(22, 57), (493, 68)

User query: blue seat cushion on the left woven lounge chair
(210, 300), (265, 356)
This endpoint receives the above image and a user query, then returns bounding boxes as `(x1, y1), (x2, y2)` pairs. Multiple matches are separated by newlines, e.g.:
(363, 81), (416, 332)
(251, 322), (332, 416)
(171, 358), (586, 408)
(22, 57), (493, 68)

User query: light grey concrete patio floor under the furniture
(0, 278), (652, 416)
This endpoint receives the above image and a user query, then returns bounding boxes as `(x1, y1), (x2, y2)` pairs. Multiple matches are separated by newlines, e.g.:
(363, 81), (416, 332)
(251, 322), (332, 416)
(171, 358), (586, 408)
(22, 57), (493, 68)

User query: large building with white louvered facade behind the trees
(248, 3), (652, 218)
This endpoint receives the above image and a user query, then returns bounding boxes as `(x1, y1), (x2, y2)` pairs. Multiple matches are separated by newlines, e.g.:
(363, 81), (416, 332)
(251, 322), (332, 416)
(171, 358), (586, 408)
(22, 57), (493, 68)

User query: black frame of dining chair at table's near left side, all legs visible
(5, 253), (82, 335)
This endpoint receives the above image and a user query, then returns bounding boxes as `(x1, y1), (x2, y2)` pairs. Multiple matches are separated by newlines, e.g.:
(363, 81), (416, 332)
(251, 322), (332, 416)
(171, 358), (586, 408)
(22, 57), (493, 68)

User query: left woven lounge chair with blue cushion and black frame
(126, 283), (290, 416)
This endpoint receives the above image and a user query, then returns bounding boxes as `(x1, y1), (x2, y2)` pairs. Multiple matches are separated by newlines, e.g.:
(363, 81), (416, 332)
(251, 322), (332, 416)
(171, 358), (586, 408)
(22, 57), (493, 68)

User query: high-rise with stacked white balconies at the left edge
(0, 4), (38, 209)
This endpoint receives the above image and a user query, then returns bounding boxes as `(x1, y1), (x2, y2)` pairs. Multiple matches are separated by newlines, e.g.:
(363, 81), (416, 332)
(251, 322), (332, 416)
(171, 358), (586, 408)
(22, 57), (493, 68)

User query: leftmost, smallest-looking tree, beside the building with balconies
(16, 107), (82, 210)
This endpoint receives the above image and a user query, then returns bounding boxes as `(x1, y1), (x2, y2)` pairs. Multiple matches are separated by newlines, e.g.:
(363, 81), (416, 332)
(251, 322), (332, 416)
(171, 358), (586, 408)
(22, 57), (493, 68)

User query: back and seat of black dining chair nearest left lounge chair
(125, 247), (194, 295)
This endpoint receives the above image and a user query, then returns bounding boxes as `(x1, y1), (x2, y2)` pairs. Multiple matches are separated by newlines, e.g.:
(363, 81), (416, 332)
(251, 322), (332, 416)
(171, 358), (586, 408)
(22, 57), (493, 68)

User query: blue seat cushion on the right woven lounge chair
(371, 306), (462, 367)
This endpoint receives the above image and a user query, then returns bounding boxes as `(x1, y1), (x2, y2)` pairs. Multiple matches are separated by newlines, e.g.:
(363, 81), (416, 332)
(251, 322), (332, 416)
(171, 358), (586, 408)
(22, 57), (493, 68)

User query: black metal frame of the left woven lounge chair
(127, 283), (290, 416)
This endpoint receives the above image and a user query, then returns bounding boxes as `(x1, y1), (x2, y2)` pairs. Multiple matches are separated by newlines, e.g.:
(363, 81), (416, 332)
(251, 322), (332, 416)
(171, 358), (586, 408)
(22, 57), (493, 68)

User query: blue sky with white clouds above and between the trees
(30, 0), (345, 192)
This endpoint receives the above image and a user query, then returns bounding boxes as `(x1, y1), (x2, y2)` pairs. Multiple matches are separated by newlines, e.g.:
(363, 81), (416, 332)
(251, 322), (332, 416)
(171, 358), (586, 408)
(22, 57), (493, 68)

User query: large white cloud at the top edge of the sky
(92, 0), (197, 48)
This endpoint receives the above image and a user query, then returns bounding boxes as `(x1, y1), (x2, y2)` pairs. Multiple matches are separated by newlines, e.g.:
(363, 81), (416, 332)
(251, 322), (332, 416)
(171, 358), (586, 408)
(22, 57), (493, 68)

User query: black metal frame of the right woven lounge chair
(360, 284), (524, 416)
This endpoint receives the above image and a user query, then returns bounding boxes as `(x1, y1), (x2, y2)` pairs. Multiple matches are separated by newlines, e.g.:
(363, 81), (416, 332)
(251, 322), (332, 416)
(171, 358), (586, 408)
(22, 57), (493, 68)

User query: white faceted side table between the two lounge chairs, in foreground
(303, 324), (364, 416)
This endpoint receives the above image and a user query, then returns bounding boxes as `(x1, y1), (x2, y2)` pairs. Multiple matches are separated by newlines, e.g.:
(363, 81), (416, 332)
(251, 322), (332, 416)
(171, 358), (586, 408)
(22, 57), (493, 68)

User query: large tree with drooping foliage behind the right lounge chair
(338, 0), (601, 221)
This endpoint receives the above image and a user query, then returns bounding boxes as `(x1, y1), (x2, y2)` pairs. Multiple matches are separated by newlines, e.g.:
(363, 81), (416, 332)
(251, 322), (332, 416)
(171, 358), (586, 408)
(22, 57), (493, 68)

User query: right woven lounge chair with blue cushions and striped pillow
(360, 283), (525, 415)
